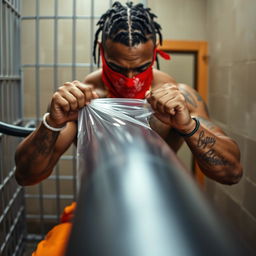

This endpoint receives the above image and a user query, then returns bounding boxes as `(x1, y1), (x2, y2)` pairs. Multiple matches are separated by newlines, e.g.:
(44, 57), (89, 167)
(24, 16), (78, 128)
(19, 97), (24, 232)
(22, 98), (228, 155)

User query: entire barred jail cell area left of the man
(0, 0), (147, 255)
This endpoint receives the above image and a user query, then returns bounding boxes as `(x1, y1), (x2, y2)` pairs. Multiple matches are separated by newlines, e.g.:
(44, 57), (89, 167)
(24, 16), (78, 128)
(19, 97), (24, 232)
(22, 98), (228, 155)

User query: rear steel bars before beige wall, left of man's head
(21, 0), (145, 246)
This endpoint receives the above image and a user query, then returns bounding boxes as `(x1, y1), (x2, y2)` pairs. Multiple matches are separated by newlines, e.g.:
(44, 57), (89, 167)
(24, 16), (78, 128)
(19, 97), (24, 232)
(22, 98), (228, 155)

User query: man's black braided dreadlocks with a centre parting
(93, 2), (162, 67)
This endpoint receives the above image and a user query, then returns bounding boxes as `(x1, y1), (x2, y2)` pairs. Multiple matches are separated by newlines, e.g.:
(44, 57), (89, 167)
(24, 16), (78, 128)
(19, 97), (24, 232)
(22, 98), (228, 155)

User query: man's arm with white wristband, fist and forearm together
(15, 81), (98, 186)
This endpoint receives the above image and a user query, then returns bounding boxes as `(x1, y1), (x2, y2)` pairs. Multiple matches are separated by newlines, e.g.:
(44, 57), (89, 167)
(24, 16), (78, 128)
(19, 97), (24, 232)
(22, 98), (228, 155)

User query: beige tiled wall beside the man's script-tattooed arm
(206, 0), (256, 252)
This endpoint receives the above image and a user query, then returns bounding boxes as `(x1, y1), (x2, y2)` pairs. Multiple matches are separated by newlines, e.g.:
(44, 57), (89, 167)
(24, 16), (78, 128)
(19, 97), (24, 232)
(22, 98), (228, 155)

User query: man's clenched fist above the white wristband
(47, 81), (98, 128)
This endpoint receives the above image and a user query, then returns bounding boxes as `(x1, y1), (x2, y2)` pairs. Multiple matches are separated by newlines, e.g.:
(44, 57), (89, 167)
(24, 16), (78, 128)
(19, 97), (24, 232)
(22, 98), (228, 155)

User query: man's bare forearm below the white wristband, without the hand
(15, 124), (59, 185)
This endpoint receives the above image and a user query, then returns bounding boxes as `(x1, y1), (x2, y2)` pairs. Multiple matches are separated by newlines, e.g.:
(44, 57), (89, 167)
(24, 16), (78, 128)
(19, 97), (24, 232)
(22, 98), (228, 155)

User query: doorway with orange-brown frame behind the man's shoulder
(159, 40), (208, 185)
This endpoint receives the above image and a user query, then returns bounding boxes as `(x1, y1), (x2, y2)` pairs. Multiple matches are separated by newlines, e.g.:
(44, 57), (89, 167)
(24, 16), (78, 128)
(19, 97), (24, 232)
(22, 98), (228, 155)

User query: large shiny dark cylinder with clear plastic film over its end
(67, 99), (245, 256)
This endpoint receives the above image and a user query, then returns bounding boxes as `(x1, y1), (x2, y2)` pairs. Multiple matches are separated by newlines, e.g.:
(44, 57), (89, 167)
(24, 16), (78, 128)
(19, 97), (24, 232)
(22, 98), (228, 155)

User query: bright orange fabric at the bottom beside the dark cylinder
(32, 202), (76, 256)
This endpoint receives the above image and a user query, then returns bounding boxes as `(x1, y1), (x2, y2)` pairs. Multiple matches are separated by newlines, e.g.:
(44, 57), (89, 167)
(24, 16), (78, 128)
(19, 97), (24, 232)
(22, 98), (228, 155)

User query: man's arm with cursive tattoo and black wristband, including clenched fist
(147, 84), (242, 184)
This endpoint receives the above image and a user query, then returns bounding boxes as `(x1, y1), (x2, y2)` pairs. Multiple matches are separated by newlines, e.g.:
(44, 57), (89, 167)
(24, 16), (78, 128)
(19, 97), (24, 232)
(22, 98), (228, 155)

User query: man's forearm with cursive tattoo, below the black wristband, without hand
(185, 119), (242, 184)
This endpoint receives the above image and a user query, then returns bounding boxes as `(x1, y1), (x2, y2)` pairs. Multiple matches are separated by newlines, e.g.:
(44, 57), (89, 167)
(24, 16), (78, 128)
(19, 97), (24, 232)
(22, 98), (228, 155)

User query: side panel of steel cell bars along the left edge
(0, 0), (25, 256)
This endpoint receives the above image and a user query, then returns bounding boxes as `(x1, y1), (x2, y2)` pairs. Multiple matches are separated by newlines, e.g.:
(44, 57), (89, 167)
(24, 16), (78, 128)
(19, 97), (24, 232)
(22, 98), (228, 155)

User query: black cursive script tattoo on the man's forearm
(196, 131), (231, 166)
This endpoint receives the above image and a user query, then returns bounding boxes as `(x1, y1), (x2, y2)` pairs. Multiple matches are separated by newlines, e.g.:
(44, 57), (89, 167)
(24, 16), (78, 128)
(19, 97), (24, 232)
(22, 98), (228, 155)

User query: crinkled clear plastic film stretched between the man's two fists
(77, 98), (153, 188)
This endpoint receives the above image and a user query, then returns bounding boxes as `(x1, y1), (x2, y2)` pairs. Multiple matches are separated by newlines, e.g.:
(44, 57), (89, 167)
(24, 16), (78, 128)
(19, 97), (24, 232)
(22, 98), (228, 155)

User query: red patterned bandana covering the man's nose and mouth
(101, 46), (170, 99)
